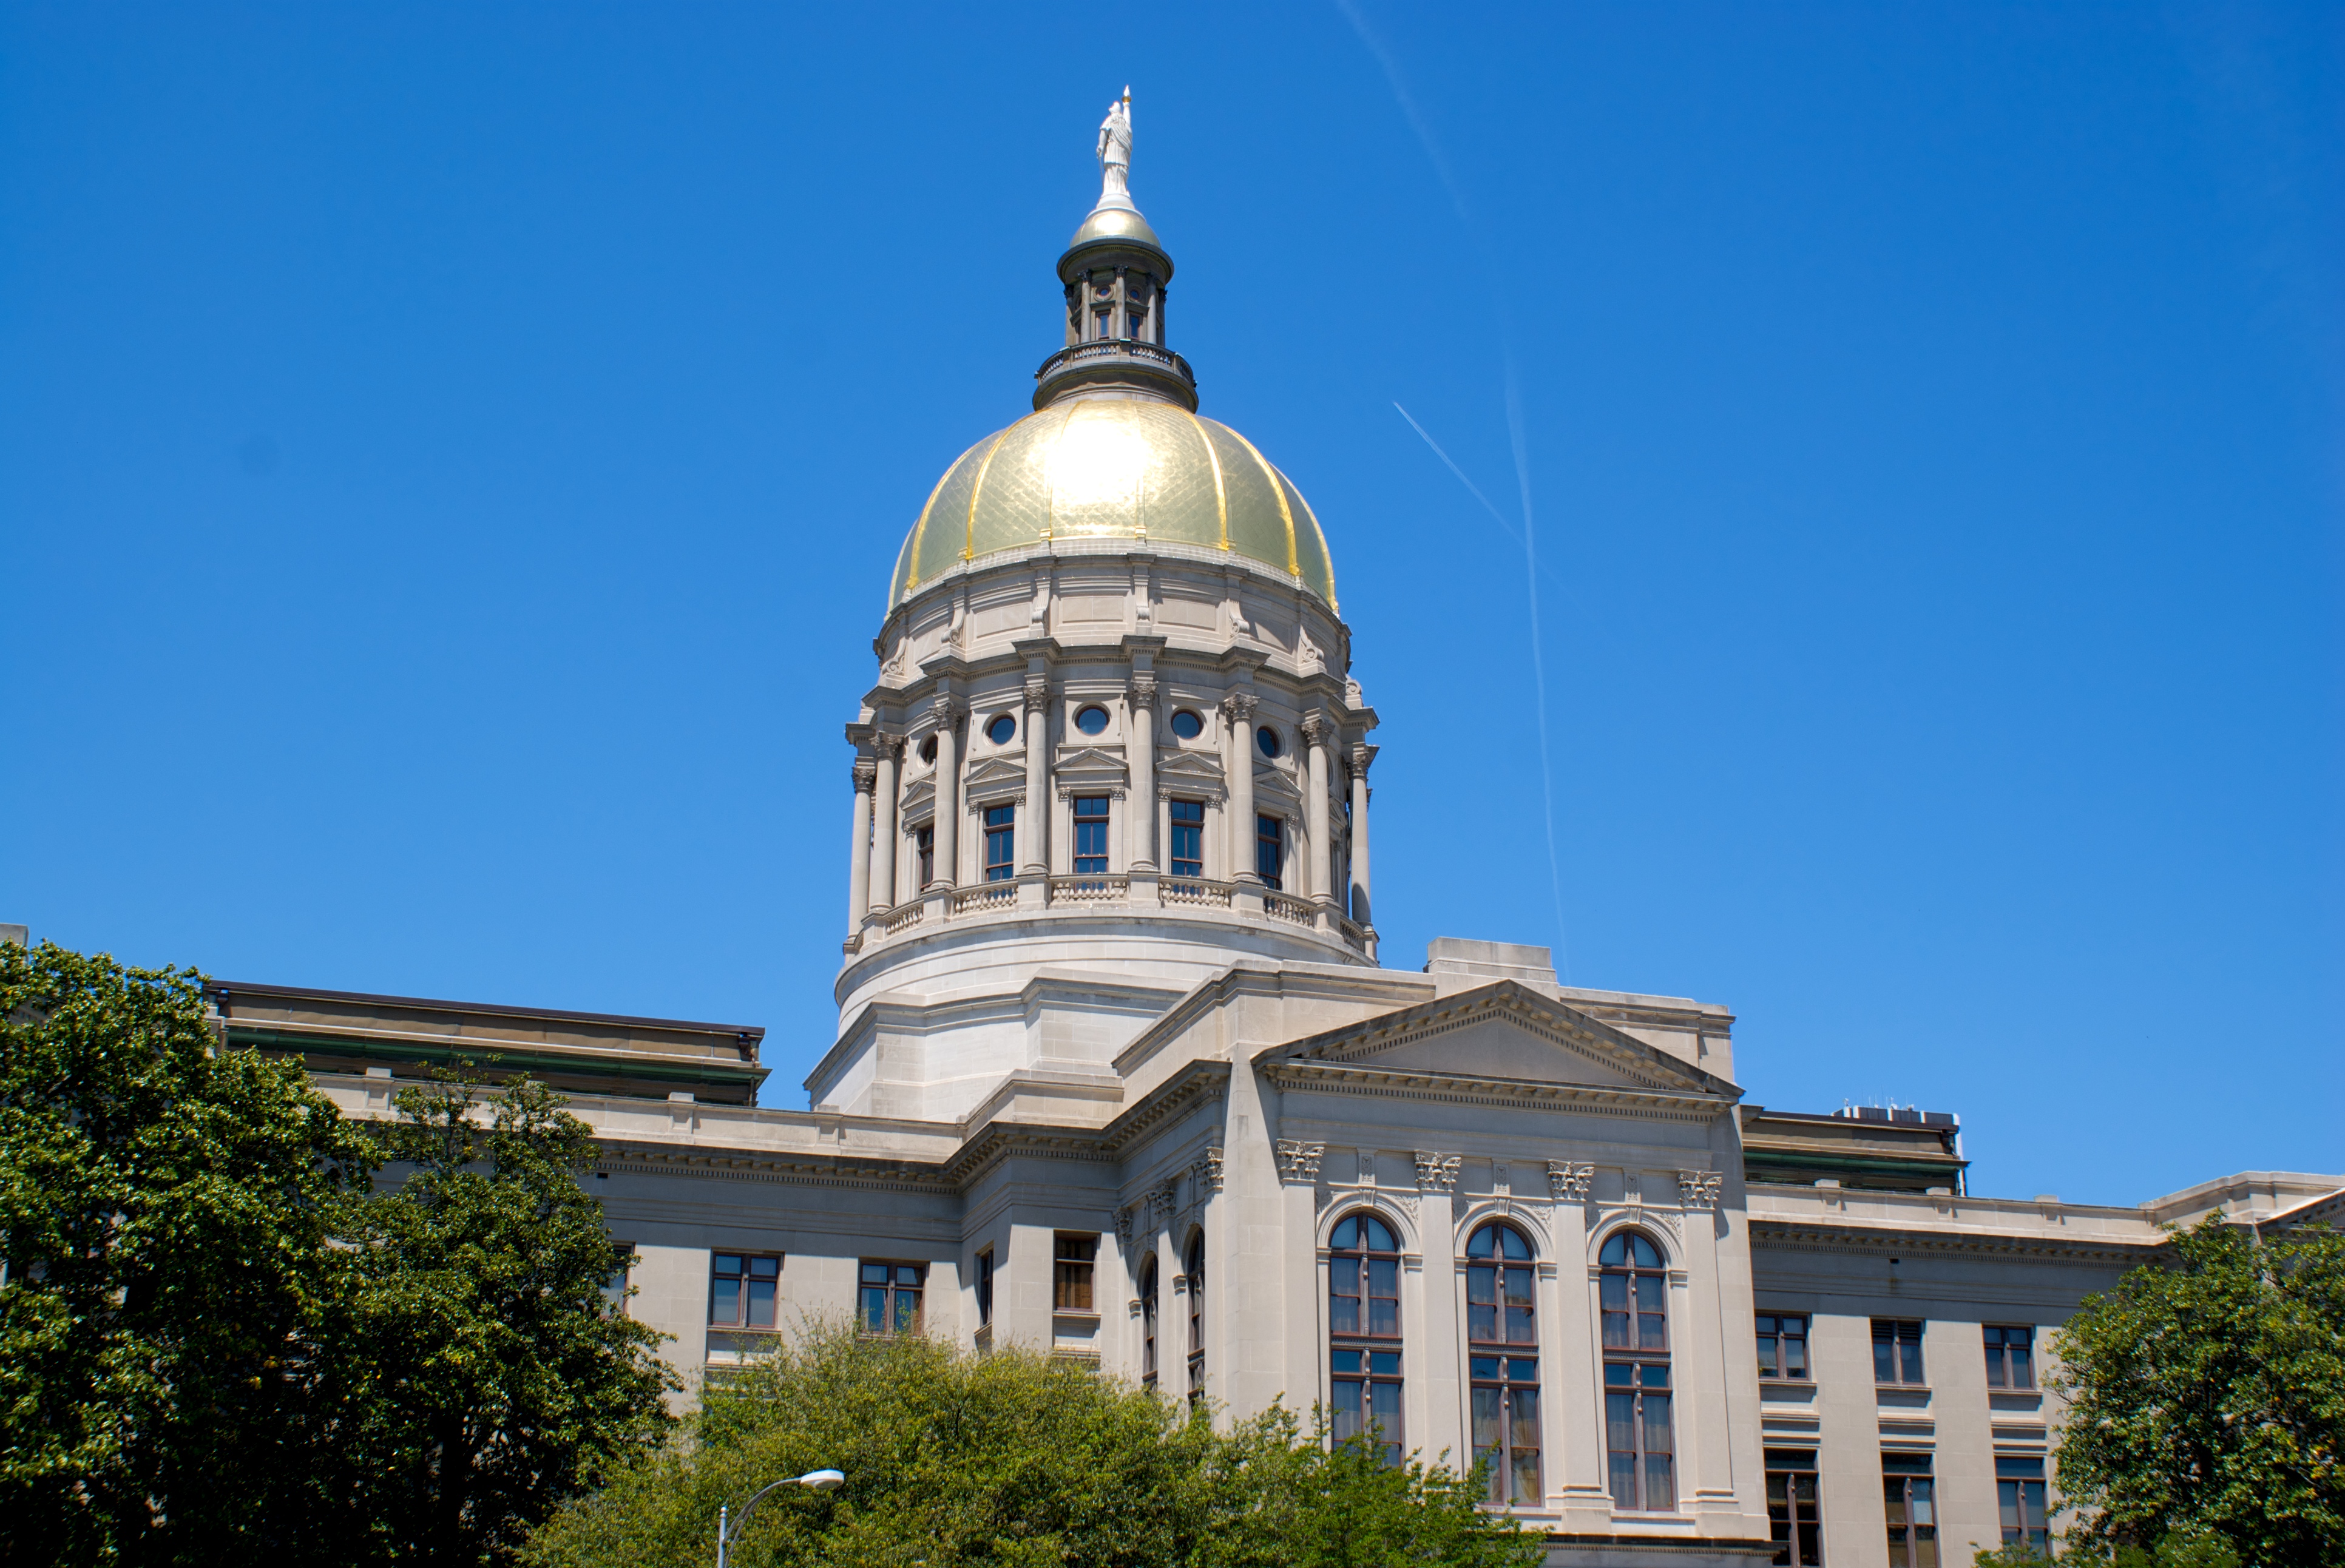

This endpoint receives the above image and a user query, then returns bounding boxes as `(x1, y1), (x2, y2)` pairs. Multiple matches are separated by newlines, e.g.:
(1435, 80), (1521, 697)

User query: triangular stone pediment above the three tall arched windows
(1257, 980), (1740, 1100)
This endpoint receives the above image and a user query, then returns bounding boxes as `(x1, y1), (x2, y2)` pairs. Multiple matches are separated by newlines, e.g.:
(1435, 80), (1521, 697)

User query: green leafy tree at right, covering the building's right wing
(2054, 1214), (2345, 1568)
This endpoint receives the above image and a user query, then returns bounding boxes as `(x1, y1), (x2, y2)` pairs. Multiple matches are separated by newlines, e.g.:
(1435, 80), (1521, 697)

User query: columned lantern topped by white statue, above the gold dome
(1034, 87), (1196, 413)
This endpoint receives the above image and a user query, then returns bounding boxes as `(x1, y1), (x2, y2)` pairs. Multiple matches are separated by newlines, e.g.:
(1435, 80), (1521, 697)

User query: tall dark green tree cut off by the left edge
(0, 942), (375, 1563)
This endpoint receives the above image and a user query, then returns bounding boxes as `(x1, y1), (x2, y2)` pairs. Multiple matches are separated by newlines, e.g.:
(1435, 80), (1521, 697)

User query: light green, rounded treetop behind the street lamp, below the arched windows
(532, 1324), (1543, 1568)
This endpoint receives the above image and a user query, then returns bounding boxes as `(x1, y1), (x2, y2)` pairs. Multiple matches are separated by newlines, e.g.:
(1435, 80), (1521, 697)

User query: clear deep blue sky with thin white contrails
(0, 0), (2345, 1202)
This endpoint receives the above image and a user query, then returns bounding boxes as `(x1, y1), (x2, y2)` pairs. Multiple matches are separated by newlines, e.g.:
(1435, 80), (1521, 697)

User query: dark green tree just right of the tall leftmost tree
(336, 1078), (678, 1568)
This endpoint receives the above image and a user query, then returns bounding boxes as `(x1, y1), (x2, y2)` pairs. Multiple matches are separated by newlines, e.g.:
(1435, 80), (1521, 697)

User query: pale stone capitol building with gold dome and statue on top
(211, 101), (2345, 1568)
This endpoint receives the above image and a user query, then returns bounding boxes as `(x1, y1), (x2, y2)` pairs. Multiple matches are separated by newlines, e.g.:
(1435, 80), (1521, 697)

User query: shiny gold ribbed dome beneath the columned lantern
(888, 399), (1336, 609)
